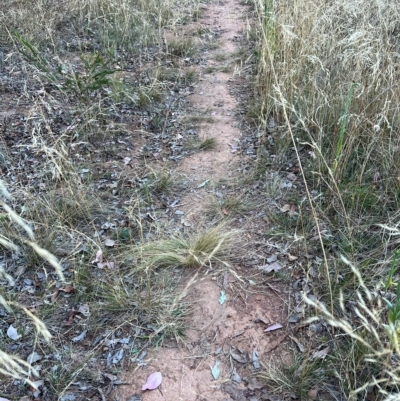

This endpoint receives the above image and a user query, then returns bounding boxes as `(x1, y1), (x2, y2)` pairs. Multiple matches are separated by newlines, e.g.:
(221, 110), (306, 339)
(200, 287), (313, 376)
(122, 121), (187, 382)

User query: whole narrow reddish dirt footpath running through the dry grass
(114, 0), (286, 401)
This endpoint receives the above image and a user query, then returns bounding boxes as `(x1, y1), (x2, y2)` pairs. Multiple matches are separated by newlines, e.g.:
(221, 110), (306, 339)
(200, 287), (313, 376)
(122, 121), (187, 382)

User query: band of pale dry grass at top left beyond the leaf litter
(0, 0), (198, 53)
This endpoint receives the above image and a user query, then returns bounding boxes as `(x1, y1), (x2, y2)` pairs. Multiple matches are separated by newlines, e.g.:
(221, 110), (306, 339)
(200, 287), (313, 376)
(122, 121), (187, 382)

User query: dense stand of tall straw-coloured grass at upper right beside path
(258, 0), (400, 203)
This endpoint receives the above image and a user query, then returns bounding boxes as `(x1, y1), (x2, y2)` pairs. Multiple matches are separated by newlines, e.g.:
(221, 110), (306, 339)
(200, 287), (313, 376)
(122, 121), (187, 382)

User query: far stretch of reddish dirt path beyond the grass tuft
(180, 0), (245, 221)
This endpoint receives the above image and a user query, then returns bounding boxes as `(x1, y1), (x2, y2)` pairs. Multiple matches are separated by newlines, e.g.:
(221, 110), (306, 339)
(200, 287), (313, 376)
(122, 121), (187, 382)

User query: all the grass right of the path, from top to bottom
(255, 0), (400, 400)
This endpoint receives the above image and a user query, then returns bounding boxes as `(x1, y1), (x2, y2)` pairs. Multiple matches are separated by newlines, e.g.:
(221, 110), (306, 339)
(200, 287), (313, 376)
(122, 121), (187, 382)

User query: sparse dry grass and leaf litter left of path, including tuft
(0, 0), (238, 400)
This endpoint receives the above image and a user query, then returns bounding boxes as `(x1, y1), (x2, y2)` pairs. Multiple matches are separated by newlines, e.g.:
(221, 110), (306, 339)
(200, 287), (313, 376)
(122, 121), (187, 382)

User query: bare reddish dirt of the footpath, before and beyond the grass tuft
(114, 0), (284, 401)
